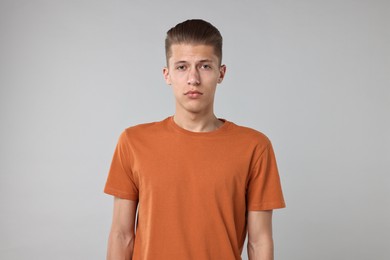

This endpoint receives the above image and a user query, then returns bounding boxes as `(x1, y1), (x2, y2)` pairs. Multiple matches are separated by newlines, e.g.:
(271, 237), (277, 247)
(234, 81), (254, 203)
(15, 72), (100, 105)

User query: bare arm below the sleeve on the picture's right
(247, 210), (274, 260)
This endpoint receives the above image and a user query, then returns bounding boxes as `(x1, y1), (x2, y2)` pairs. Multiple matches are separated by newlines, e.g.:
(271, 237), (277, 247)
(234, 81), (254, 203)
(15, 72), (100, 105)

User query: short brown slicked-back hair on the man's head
(165, 19), (222, 64)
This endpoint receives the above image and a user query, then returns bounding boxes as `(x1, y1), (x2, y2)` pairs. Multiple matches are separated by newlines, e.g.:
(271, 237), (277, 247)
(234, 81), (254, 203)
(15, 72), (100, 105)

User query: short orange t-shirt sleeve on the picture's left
(104, 131), (138, 201)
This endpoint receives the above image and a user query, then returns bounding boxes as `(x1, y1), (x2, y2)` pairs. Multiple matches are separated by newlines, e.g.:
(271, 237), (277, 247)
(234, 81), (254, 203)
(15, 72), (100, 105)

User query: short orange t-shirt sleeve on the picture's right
(246, 140), (286, 211)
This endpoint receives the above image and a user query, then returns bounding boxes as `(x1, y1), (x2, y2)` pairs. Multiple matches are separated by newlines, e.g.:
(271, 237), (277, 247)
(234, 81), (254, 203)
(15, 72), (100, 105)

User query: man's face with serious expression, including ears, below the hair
(163, 44), (226, 114)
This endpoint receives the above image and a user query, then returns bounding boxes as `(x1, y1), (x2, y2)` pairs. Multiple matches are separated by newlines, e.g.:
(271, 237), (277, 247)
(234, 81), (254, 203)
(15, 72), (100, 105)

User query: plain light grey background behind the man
(0, 0), (390, 260)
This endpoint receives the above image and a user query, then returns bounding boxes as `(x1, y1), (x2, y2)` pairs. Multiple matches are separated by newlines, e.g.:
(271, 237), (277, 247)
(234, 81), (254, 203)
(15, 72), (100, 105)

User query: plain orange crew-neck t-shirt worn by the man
(104, 117), (285, 260)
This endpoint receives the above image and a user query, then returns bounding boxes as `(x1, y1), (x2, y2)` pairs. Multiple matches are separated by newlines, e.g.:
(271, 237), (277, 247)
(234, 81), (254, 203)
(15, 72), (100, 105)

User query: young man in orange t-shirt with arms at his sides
(105, 20), (285, 260)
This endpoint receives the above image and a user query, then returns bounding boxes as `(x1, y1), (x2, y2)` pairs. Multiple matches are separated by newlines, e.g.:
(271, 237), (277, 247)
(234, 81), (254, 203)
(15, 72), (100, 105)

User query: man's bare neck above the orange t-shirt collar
(173, 110), (223, 132)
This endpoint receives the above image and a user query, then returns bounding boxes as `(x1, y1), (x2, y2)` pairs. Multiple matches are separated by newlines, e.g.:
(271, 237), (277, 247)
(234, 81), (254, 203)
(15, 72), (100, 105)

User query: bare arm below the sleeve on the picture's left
(107, 197), (138, 260)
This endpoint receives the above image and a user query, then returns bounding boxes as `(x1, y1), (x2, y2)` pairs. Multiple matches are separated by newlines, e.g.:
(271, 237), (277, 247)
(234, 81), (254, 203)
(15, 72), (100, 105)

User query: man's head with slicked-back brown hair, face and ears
(163, 20), (226, 115)
